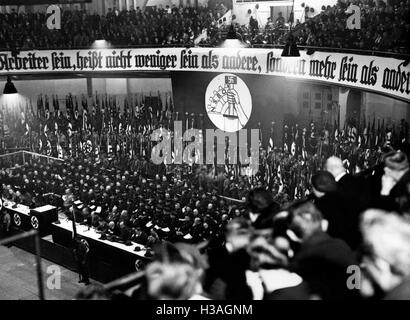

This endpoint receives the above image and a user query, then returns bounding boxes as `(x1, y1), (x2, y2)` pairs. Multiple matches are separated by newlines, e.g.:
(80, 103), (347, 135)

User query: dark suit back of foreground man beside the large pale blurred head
(291, 231), (358, 300)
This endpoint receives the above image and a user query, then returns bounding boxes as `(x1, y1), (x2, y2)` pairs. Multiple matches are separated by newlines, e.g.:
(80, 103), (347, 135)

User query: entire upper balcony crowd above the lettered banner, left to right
(0, 0), (410, 54)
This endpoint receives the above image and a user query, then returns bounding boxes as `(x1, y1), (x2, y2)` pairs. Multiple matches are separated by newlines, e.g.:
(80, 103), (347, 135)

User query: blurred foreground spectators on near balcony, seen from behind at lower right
(77, 151), (410, 300)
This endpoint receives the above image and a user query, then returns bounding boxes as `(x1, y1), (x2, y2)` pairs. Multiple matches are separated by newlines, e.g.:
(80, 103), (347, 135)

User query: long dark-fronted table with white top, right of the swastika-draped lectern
(51, 218), (151, 281)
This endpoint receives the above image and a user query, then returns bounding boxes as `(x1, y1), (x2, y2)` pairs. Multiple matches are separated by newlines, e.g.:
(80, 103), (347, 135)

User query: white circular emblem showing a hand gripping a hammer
(205, 73), (252, 132)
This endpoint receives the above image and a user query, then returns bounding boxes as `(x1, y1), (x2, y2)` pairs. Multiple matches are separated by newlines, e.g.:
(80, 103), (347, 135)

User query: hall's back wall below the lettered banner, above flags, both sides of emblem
(2, 72), (410, 135)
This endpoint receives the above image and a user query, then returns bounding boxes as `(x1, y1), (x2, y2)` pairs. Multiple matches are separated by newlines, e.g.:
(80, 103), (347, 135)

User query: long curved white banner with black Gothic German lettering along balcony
(0, 48), (410, 101)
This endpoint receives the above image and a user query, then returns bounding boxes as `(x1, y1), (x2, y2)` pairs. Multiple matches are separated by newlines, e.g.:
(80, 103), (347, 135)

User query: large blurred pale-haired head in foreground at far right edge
(360, 209), (410, 295)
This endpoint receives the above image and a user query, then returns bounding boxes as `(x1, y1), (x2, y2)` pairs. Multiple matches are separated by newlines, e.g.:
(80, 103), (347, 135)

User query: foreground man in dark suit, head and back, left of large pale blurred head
(289, 201), (358, 300)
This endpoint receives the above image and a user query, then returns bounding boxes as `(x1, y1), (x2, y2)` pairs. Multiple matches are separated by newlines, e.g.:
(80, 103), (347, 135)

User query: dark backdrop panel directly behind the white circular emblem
(171, 72), (299, 145)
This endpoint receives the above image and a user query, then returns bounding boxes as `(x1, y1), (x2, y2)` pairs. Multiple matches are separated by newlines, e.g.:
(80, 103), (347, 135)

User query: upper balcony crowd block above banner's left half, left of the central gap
(0, 5), (221, 50)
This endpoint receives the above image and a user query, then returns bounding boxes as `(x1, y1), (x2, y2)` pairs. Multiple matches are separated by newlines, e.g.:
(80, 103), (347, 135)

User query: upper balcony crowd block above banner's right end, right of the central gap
(296, 0), (410, 54)
